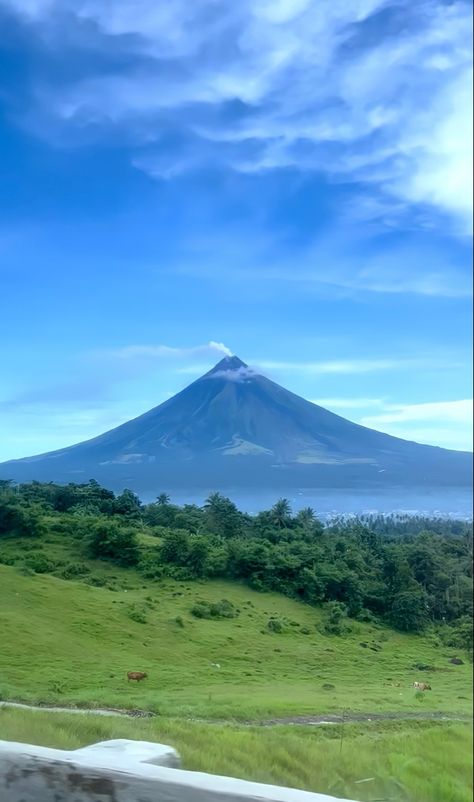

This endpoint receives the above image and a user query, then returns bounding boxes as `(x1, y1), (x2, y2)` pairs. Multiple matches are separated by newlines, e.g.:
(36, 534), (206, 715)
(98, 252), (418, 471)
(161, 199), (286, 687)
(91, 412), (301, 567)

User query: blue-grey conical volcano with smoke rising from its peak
(0, 356), (472, 494)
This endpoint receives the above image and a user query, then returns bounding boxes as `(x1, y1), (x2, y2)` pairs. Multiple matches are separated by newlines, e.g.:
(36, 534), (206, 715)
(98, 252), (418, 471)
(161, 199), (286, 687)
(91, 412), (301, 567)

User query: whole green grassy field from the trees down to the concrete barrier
(0, 524), (472, 802)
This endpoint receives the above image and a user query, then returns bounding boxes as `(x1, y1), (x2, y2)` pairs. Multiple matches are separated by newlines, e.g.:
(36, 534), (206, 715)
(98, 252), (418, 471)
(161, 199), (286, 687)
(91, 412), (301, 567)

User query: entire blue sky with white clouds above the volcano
(0, 0), (472, 459)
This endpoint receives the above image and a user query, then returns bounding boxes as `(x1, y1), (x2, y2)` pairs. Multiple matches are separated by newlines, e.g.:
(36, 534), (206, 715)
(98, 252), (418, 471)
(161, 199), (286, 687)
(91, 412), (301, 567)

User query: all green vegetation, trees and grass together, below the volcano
(0, 482), (473, 802)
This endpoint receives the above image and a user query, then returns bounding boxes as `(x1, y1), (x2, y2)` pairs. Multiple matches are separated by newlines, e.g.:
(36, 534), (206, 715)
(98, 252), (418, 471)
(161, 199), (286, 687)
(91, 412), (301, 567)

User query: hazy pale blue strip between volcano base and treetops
(143, 487), (473, 520)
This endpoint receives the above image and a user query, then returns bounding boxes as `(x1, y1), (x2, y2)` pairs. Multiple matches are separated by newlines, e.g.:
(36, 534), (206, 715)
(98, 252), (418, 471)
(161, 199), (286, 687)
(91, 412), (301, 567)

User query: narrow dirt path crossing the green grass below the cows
(0, 700), (472, 727)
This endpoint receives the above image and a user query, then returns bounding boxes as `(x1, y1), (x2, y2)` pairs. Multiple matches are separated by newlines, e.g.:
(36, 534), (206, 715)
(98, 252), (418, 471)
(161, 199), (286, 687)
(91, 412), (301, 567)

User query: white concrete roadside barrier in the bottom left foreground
(0, 740), (356, 802)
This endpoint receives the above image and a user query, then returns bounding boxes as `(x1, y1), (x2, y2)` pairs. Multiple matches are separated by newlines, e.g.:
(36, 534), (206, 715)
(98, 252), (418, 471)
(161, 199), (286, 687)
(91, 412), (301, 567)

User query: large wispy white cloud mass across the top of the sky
(3, 0), (472, 232)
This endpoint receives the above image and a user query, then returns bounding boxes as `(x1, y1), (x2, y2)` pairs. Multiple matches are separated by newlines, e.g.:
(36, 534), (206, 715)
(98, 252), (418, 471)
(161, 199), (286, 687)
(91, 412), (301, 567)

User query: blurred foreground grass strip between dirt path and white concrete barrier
(0, 709), (472, 802)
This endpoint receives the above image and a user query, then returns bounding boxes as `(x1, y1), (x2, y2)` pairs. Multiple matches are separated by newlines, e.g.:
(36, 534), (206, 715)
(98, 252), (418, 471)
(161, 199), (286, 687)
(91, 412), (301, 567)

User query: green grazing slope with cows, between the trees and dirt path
(0, 562), (472, 719)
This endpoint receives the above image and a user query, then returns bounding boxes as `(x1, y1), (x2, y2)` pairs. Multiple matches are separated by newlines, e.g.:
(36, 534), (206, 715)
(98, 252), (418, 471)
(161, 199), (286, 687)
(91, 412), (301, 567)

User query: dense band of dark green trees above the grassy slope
(0, 480), (472, 652)
